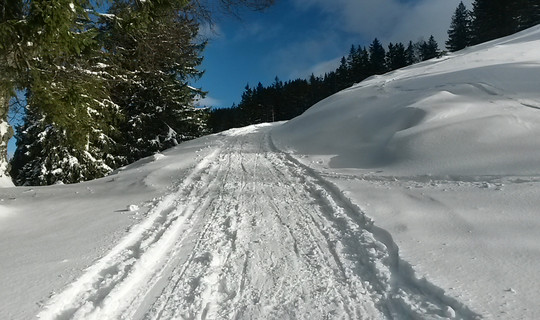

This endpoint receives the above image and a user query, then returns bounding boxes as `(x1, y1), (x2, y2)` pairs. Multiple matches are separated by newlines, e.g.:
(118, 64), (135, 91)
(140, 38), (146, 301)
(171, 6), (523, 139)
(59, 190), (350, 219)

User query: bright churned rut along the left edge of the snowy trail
(37, 149), (220, 319)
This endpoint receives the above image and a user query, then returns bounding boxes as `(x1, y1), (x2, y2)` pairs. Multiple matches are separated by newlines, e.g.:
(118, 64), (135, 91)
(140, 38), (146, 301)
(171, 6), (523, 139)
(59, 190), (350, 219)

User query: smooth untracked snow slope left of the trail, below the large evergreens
(0, 138), (221, 319)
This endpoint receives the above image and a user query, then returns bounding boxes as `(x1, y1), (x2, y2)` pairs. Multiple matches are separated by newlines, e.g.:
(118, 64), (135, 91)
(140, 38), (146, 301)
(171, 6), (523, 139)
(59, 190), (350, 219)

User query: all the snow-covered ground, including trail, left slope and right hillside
(0, 27), (540, 319)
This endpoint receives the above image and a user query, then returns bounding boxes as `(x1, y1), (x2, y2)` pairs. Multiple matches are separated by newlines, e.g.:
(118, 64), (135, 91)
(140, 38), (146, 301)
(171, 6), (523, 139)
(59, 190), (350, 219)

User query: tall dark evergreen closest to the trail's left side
(105, 0), (207, 162)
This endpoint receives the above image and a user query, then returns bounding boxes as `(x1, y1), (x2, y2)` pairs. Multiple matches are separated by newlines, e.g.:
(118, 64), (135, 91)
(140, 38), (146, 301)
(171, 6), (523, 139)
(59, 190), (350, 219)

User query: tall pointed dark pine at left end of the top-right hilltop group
(446, 2), (471, 52)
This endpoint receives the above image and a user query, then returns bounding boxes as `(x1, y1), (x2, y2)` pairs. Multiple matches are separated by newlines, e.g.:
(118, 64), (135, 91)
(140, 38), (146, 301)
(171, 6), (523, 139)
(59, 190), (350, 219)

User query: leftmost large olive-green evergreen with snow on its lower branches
(4, 0), (121, 184)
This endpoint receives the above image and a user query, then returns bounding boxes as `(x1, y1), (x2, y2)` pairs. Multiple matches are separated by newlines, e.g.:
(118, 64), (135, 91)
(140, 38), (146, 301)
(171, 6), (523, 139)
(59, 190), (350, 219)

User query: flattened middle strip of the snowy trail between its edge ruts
(140, 134), (381, 319)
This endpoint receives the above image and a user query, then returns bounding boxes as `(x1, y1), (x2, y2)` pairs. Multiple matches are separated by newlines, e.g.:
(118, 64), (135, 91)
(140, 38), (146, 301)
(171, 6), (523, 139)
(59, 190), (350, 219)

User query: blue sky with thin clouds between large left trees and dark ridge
(195, 0), (472, 107)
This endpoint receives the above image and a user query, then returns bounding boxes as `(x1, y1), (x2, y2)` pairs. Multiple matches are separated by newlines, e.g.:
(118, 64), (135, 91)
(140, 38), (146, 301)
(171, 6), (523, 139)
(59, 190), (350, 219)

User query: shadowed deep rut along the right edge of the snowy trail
(269, 134), (481, 319)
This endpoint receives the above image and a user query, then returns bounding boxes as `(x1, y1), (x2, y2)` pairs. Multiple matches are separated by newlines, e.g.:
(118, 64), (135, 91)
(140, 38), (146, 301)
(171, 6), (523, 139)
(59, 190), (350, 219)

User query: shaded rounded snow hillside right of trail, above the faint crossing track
(275, 27), (540, 176)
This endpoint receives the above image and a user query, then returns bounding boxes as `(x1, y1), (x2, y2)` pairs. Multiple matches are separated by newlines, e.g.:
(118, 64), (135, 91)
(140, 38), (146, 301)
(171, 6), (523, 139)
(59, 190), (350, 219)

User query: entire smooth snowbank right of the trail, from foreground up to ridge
(273, 27), (540, 319)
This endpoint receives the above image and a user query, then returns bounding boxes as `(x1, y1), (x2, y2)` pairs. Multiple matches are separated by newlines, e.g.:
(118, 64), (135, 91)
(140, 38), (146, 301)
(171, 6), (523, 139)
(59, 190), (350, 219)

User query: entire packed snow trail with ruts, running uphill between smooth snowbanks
(38, 128), (479, 320)
